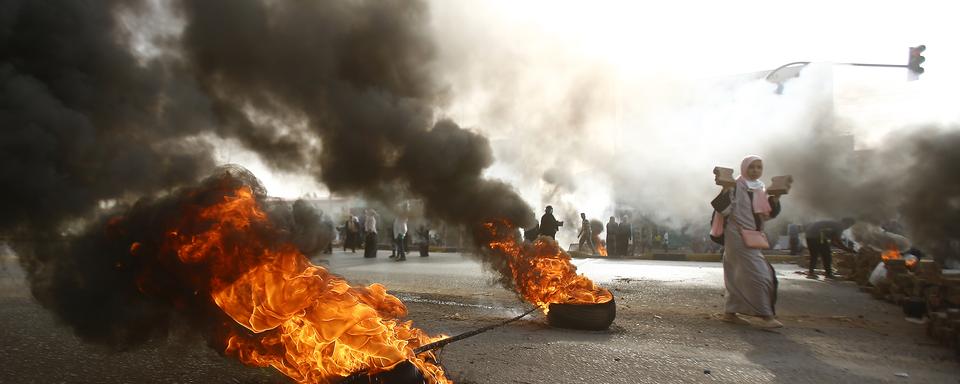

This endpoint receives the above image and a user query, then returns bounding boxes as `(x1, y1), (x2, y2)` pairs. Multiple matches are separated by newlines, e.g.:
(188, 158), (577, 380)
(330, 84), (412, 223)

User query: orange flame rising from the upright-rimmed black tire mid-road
(484, 221), (613, 313)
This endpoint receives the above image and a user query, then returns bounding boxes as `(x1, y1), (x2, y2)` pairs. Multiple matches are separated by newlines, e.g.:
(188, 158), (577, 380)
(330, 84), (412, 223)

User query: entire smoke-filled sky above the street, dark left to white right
(7, 0), (960, 249)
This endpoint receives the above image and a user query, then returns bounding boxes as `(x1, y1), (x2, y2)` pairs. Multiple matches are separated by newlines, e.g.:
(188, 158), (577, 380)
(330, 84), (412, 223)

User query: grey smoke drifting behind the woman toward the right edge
(768, 127), (960, 261)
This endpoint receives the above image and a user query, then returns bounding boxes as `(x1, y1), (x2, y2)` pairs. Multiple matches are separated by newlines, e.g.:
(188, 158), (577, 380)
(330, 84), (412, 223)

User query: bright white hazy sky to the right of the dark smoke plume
(422, 1), (960, 238)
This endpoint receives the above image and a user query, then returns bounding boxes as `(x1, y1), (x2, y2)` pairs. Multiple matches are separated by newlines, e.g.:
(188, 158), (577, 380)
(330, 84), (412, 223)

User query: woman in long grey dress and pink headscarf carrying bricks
(710, 156), (783, 328)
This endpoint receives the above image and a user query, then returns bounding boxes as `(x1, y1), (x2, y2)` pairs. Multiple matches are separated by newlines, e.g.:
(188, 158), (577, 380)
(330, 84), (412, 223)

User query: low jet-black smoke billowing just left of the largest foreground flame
(20, 167), (270, 351)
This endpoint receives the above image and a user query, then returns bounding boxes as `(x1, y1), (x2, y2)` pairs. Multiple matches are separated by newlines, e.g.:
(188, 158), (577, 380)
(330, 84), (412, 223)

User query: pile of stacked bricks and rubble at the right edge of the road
(834, 247), (960, 354)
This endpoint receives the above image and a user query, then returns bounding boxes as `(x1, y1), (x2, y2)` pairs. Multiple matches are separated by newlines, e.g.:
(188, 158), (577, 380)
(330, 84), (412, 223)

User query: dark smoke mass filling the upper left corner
(0, 0), (213, 232)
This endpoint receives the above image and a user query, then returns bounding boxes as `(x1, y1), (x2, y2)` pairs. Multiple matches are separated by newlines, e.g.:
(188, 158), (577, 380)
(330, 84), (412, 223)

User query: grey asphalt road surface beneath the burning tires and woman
(0, 251), (960, 383)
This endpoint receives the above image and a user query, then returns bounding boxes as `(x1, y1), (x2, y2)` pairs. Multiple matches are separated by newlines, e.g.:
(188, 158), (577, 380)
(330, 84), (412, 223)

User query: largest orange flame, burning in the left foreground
(164, 187), (450, 383)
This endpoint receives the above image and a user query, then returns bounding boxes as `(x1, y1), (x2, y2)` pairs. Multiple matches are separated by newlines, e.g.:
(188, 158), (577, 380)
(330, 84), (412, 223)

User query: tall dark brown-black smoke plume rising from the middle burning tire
(171, 0), (533, 226)
